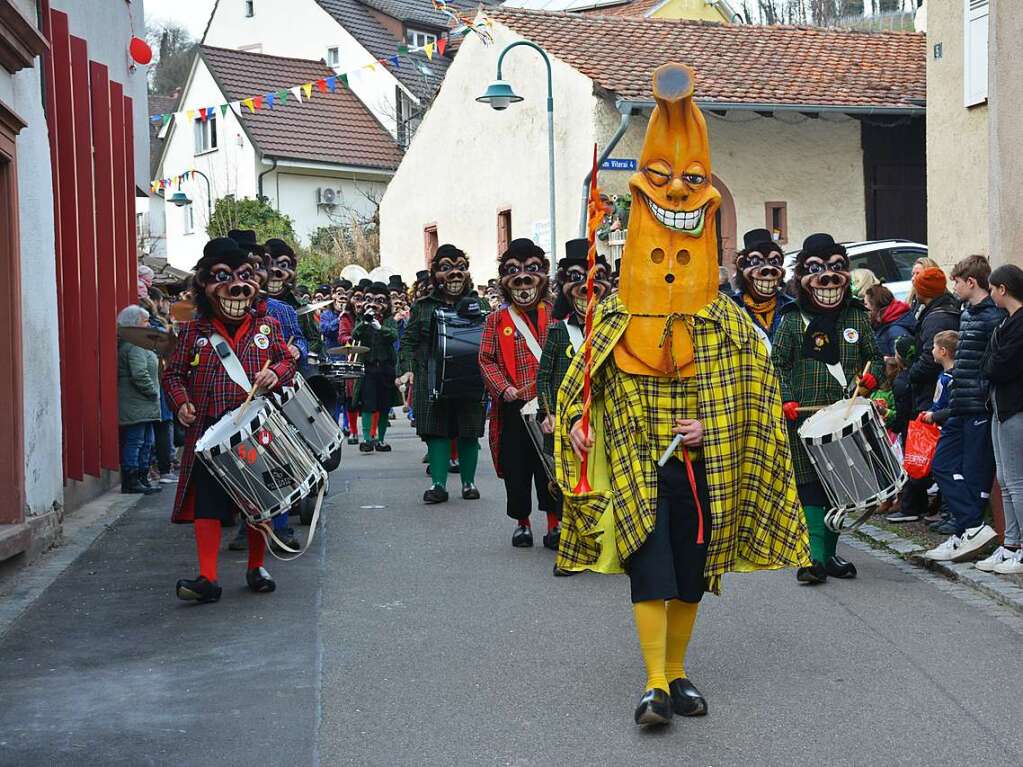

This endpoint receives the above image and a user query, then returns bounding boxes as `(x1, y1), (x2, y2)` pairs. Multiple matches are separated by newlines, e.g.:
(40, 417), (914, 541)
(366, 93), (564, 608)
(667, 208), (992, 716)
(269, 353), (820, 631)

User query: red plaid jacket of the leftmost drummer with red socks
(163, 305), (295, 523)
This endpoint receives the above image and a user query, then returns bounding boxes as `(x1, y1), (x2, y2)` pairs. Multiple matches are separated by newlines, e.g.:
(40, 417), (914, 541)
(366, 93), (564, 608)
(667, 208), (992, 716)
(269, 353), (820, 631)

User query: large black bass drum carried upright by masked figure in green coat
(427, 309), (484, 402)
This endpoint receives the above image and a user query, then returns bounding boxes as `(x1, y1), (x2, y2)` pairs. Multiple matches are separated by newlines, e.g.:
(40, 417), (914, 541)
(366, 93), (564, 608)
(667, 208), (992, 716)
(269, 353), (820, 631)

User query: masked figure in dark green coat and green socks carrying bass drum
(398, 244), (486, 503)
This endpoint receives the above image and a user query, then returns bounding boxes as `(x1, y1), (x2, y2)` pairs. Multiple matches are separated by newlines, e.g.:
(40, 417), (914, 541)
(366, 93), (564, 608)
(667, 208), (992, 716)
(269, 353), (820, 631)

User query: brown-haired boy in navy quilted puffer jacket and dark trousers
(925, 256), (1006, 561)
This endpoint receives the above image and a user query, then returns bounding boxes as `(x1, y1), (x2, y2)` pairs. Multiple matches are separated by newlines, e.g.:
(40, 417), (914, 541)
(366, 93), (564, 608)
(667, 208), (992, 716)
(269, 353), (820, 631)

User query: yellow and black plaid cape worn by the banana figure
(554, 294), (810, 593)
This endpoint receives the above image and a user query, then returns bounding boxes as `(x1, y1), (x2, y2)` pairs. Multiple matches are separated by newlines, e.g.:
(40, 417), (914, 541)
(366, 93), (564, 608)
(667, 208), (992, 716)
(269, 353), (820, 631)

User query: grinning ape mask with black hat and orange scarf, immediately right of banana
(735, 229), (793, 349)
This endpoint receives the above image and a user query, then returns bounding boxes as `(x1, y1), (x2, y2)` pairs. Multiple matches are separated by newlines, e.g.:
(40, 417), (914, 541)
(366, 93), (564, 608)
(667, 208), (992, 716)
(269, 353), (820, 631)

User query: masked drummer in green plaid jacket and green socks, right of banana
(771, 234), (884, 584)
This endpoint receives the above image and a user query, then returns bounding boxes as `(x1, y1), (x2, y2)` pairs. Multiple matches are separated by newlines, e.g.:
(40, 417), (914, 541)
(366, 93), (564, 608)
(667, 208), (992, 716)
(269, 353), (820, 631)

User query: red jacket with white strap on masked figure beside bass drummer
(480, 303), (551, 477)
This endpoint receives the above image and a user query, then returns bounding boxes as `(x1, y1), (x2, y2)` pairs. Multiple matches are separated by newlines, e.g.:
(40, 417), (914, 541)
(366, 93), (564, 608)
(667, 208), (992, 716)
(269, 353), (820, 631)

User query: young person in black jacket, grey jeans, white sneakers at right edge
(977, 264), (1023, 575)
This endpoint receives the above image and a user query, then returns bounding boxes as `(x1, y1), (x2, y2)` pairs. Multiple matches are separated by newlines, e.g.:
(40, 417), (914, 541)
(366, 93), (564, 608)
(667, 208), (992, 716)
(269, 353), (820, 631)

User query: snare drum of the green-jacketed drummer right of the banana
(799, 397), (906, 533)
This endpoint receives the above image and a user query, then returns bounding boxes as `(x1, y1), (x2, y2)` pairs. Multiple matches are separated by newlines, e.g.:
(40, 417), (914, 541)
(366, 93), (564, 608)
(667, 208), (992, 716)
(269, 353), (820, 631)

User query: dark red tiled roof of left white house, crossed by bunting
(199, 45), (401, 170)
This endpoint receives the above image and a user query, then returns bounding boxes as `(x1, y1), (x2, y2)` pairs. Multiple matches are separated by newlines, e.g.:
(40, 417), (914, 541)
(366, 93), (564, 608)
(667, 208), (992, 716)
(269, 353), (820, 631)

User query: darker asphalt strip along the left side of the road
(0, 489), (324, 767)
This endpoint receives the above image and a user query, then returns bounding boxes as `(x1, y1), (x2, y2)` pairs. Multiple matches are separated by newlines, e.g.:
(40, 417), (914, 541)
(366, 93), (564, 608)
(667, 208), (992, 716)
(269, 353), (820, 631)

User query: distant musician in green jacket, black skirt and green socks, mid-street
(352, 282), (401, 453)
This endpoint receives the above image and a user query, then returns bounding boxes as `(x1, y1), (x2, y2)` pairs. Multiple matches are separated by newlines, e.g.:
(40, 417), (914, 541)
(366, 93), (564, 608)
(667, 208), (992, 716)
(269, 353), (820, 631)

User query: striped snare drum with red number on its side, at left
(195, 397), (326, 526)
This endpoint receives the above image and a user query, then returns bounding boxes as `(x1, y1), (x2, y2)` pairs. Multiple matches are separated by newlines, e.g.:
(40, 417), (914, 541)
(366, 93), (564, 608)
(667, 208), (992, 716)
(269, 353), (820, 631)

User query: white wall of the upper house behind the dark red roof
(204, 0), (403, 135)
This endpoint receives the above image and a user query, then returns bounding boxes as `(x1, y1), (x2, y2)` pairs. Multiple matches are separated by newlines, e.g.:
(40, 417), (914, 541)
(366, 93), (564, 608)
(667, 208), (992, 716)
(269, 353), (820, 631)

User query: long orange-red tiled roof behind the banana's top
(487, 6), (927, 109)
